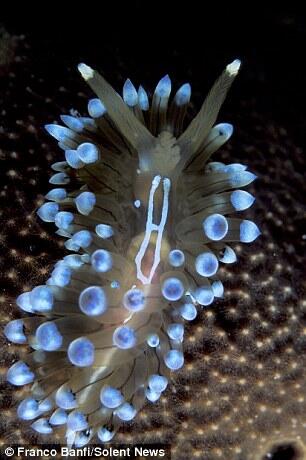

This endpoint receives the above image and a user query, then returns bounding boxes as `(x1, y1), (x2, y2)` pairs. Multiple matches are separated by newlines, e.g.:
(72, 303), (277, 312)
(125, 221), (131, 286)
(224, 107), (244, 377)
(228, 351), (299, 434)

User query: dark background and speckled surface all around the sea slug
(0, 2), (306, 460)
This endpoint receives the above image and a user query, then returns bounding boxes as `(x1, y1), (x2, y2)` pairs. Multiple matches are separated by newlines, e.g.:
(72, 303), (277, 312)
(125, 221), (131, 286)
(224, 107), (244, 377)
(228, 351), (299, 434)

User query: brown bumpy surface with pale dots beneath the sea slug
(0, 29), (306, 460)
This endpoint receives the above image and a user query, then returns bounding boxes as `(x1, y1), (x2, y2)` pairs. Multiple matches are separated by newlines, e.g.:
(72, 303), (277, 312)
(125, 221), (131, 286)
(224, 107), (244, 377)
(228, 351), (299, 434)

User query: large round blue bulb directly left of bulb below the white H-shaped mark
(79, 286), (108, 316)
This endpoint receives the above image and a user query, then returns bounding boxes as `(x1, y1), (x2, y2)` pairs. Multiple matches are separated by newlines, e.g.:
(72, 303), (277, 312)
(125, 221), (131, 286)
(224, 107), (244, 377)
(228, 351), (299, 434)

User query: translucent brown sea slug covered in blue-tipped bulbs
(5, 60), (260, 447)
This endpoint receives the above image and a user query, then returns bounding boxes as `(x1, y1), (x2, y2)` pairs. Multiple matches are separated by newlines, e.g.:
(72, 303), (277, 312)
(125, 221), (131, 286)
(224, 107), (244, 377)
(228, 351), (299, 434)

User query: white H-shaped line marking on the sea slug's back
(135, 176), (171, 284)
